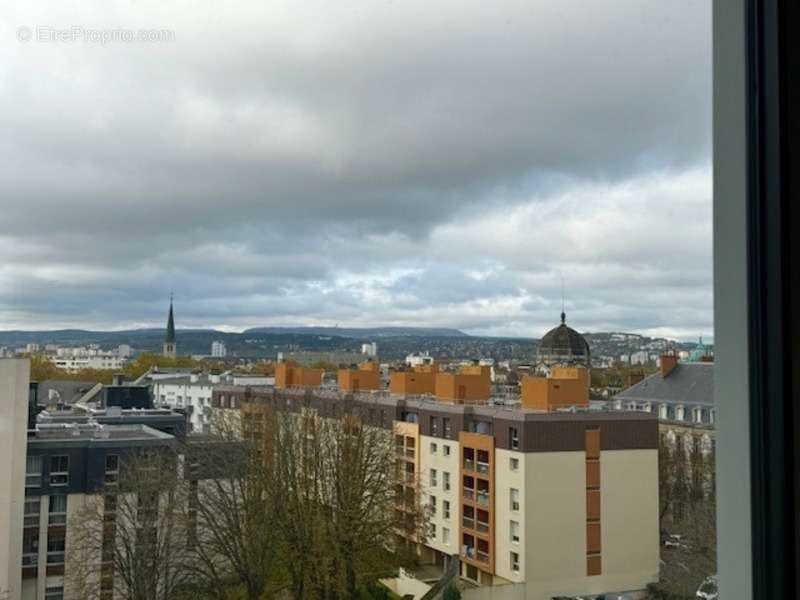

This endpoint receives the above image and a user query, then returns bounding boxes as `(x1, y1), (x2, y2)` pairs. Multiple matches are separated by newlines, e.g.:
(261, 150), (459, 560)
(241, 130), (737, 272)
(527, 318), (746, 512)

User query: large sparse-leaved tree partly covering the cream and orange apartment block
(269, 400), (426, 600)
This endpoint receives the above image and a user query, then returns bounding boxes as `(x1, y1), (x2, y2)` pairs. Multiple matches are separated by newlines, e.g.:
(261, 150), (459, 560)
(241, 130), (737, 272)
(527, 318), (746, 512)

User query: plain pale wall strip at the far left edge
(0, 359), (30, 600)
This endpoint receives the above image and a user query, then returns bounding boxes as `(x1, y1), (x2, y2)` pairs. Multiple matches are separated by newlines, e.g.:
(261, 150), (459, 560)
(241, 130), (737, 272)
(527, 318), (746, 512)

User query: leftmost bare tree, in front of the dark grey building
(66, 447), (189, 600)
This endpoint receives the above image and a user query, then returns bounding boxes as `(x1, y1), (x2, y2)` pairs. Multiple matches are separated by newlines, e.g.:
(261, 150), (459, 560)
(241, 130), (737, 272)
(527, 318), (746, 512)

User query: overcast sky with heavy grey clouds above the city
(0, 0), (713, 339)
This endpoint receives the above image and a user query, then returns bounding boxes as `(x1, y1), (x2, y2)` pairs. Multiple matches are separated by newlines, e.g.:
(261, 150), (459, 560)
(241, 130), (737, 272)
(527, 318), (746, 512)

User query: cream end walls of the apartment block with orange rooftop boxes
(478, 450), (659, 600)
